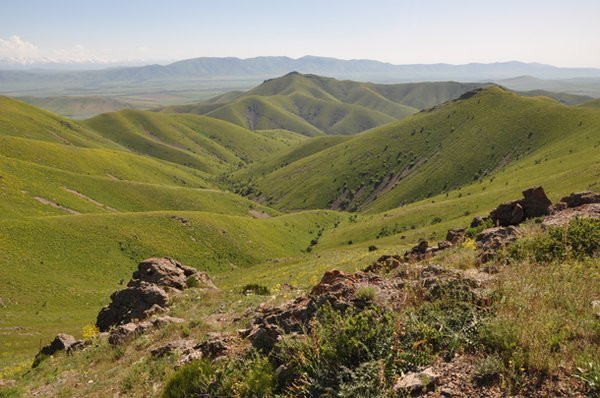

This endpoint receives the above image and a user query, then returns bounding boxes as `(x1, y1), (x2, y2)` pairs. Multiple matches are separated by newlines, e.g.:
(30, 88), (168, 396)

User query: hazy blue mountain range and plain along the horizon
(0, 56), (600, 95)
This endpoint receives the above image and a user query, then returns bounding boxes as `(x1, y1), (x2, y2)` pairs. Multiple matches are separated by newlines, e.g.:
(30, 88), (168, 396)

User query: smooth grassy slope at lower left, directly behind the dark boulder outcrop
(0, 211), (339, 365)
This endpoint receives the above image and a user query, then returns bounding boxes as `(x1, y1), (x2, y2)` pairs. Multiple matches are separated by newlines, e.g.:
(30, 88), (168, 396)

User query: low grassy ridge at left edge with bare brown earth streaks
(0, 156), (276, 218)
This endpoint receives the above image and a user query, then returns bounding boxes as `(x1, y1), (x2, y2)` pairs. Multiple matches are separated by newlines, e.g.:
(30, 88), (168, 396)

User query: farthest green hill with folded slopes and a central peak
(162, 72), (482, 136)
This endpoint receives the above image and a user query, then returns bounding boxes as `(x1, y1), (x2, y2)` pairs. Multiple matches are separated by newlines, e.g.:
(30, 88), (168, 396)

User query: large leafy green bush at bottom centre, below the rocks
(276, 305), (397, 396)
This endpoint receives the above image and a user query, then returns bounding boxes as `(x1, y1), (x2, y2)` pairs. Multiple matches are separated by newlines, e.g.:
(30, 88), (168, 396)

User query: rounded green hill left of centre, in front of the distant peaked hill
(83, 110), (300, 173)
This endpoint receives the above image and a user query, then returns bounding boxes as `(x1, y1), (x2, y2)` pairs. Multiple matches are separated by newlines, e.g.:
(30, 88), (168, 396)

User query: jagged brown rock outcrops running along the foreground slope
(25, 187), (600, 397)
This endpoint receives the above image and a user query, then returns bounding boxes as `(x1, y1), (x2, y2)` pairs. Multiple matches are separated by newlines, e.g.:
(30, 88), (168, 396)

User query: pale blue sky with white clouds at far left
(0, 0), (600, 67)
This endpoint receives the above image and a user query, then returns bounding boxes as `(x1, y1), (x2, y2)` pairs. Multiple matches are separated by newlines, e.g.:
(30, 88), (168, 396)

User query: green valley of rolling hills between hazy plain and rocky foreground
(0, 73), (600, 396)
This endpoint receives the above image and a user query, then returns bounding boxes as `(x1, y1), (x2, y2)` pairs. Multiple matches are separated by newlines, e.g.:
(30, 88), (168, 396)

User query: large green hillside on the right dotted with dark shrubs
(233, 87), (600, 210)
